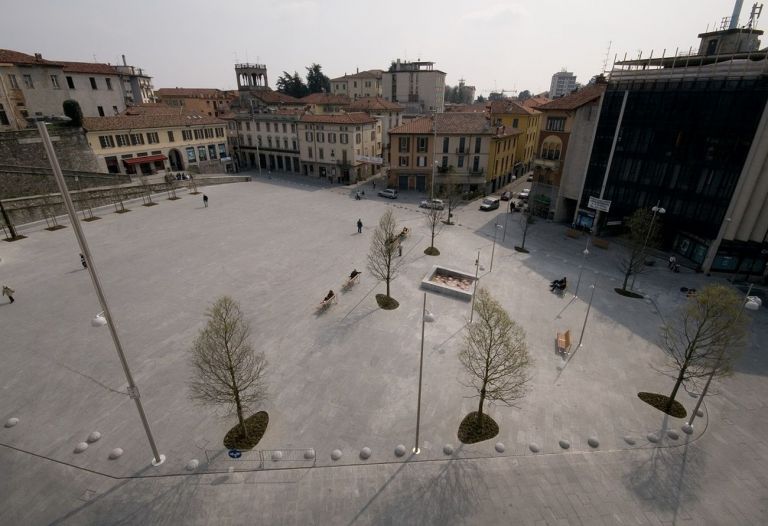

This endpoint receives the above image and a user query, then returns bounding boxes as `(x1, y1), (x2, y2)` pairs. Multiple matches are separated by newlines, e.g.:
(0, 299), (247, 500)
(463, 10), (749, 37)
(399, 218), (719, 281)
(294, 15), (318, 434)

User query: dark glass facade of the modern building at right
(577, 77), (768, 270)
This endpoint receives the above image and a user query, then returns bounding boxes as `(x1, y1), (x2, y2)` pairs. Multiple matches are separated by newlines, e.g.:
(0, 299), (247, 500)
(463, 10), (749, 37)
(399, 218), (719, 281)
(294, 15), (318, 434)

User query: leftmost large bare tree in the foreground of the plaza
(189, 296), (267, 439)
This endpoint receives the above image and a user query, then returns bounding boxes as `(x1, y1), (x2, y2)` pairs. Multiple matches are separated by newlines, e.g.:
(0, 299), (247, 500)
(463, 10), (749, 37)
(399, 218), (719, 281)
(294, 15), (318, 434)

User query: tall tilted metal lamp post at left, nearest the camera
(37, 121), (165, 466)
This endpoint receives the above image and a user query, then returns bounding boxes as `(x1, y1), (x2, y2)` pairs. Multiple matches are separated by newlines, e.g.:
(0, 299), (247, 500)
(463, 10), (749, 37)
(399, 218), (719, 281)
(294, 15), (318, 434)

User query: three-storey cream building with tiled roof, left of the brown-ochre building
(298, 112), (382, 182)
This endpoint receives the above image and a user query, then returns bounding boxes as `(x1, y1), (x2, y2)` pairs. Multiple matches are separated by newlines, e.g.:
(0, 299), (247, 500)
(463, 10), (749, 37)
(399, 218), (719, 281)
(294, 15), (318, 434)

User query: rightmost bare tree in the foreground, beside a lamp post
(661, 285), (748, 411)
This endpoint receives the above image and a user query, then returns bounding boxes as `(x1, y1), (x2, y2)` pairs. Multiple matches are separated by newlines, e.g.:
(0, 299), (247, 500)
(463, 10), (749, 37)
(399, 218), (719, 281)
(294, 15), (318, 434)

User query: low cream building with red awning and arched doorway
(83, 111), (232, 175)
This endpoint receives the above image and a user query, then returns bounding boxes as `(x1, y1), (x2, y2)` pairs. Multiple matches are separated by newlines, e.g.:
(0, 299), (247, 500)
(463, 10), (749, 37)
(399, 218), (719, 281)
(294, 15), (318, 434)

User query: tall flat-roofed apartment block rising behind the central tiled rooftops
(381, 59), (445, 115)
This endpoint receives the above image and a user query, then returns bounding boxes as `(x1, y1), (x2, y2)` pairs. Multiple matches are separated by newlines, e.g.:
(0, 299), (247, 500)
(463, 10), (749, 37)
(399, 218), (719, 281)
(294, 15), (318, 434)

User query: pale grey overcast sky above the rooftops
(0, 0), (752, 94)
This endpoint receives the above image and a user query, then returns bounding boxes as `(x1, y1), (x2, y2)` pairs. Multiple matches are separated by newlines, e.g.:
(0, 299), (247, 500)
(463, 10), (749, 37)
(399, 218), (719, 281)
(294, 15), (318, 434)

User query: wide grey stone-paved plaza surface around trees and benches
(0, 174), (768, 524)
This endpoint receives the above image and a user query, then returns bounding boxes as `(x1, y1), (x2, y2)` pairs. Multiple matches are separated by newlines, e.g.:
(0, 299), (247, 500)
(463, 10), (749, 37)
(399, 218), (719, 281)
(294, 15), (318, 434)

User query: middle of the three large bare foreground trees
(459, 288), (531, 426)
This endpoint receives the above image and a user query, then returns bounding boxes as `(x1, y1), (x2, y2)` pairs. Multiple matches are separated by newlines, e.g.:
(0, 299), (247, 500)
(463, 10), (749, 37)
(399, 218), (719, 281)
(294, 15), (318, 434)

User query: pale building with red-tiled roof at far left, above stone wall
(0, 49), (151, 131)
